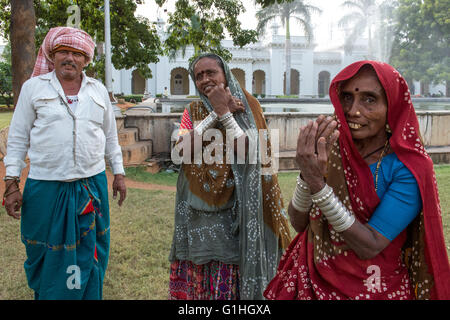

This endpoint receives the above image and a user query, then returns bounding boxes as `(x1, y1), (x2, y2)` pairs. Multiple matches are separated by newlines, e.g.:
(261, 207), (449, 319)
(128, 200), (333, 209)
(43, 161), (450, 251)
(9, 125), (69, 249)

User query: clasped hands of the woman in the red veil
(296, 115), (339, 193)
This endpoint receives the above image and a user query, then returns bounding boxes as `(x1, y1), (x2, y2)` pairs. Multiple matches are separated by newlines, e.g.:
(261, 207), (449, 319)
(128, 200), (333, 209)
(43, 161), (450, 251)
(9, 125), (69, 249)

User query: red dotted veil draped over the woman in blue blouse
(265, 61), (450, 299)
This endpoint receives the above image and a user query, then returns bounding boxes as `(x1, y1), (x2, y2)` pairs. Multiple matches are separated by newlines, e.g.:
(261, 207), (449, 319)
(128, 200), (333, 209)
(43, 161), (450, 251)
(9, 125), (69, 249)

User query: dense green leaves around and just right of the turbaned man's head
(0, 0), (162, 79)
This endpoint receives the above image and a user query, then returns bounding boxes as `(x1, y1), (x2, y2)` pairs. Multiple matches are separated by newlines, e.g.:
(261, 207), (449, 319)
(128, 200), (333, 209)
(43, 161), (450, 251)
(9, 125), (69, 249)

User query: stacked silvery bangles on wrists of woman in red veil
(292, 174), (355, 232)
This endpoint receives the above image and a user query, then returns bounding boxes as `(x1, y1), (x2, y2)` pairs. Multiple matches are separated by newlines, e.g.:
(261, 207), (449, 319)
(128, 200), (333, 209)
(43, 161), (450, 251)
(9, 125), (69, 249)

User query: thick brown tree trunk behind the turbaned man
(10, 0), (36, 106)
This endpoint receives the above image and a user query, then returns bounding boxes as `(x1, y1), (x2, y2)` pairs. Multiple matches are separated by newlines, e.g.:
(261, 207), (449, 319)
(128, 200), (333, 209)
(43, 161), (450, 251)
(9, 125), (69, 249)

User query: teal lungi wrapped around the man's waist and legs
(21, 171), (110, 300)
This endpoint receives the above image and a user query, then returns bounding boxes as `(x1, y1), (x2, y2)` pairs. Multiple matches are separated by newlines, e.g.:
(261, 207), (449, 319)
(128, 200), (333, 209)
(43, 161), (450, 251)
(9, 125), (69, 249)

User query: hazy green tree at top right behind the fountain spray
(390, 0), (450, 84)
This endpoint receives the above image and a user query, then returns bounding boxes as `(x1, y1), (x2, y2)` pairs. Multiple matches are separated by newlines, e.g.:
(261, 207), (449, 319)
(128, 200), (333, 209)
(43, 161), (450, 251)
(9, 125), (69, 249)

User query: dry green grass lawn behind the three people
(0, 166), (450, 300)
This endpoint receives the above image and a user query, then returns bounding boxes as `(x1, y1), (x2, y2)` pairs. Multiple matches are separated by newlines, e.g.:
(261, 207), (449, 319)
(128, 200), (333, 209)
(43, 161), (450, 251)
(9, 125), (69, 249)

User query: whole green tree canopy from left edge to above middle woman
(0, 0), (270, 74)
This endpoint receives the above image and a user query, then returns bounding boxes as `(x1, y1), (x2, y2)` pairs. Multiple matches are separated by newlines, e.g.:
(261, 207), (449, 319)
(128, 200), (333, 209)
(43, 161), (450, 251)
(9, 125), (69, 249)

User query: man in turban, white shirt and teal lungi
(3, 27), (126, 299)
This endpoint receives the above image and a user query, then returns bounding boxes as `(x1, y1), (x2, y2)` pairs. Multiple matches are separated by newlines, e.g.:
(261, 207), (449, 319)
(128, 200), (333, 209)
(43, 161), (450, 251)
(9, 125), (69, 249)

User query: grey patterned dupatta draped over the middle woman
(170, 54), (282, 300)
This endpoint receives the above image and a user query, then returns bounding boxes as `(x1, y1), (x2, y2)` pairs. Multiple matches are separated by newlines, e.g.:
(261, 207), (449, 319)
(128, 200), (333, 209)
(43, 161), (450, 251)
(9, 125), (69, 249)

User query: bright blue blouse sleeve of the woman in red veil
(368, 156), (422, 241)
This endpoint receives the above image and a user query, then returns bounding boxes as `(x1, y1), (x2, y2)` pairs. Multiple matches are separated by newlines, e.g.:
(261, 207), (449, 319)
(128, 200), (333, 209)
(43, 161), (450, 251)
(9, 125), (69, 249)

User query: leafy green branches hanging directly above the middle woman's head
(156, 0), (257, 61)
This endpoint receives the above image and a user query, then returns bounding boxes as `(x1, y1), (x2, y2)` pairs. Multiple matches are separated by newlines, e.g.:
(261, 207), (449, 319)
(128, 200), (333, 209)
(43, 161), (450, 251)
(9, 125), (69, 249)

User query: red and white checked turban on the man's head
(31, 27), (95, 77)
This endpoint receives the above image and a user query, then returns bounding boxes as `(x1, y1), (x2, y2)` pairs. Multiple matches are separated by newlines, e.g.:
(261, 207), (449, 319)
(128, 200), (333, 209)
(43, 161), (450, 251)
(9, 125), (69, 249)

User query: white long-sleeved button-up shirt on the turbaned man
(4, 71), (125, 181)
